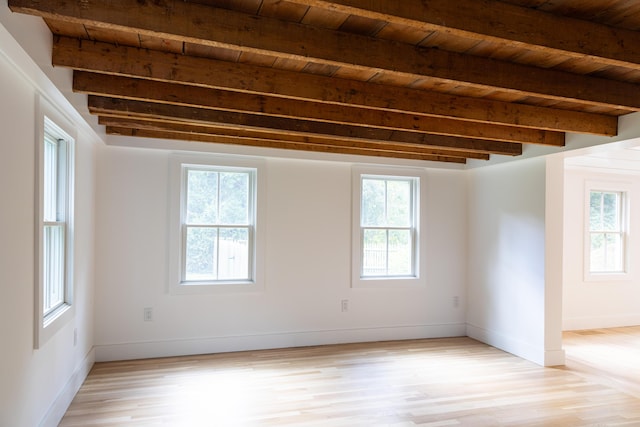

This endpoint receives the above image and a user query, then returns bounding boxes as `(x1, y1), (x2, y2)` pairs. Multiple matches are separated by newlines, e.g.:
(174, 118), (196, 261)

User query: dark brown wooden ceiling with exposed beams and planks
(8, 0), (640, 163)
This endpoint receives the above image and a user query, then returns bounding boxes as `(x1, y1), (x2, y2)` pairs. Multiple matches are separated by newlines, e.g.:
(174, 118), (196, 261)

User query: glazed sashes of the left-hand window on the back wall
(181, 165), (256, 284)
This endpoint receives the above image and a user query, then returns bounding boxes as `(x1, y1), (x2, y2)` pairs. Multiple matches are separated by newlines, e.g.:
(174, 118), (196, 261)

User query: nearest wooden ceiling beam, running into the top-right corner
(289, 0), (640, 69)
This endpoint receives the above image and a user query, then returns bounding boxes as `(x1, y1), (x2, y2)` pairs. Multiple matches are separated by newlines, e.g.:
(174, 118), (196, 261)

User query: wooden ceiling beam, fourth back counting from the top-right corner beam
(73, 71), (564, 146)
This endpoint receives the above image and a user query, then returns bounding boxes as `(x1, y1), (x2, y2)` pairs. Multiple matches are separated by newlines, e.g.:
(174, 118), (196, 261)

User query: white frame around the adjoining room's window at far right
(583, 181), (631, 282)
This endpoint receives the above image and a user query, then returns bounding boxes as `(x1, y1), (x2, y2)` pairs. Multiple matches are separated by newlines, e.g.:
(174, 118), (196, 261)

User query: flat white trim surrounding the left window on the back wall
(165, 153), (267, 295)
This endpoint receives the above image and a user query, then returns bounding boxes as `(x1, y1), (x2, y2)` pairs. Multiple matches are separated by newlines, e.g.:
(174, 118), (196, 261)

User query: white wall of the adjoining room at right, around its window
(563, 168), (640, 330)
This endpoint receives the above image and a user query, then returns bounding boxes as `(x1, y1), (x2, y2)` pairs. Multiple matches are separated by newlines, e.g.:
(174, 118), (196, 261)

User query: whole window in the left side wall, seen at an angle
(36, 117), (73, 348)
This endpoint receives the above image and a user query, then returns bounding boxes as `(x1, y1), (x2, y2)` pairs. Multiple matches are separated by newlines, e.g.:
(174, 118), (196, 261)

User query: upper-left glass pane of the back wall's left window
(186, 170), (218, 224)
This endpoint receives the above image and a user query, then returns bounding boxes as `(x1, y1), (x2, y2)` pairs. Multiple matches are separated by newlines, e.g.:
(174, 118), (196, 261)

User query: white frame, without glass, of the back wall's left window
(167, 153), (266, 295)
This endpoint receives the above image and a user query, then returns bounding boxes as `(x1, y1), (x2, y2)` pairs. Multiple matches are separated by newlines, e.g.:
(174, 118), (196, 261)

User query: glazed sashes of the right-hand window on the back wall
(360, 175), (419, 279)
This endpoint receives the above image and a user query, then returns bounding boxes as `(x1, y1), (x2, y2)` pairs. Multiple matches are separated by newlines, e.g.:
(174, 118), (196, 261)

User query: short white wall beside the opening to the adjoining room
(467, 158), (559, 365)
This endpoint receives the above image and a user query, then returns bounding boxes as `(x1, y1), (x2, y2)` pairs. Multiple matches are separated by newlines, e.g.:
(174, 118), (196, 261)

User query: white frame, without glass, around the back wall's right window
(351, 166), (427, 288)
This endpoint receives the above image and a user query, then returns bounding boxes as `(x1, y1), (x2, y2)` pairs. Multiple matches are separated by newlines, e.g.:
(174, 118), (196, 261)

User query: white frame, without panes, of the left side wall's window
(34, 105), (75, 349)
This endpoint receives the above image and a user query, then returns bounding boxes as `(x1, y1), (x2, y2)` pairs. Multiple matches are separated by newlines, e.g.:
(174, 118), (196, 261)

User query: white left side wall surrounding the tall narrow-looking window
(0, 29), (95, 426)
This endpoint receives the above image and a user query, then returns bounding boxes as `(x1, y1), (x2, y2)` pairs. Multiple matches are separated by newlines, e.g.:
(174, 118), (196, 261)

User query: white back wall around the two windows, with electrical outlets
(96, 146), (466, 360)
